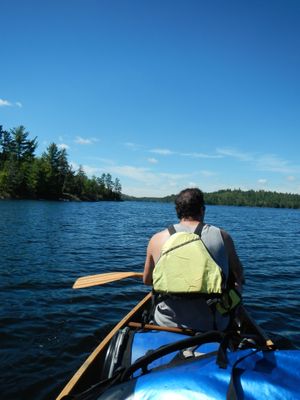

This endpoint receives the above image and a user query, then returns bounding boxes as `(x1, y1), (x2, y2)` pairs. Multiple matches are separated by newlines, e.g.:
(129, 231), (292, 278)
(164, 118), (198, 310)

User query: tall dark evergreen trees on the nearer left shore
(0, 126), (122, 201)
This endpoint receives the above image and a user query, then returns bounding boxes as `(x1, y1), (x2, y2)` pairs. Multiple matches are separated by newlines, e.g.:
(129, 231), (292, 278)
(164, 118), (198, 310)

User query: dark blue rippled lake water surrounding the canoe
(0, 201), (300, 400)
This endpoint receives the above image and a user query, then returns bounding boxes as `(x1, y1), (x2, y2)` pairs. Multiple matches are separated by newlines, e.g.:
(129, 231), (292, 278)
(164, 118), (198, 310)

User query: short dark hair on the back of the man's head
(175, 188), (205, 219)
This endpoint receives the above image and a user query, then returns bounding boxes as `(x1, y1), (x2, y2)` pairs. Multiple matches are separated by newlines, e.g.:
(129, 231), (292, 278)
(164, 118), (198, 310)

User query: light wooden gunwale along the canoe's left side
(56, 292), (152, 400)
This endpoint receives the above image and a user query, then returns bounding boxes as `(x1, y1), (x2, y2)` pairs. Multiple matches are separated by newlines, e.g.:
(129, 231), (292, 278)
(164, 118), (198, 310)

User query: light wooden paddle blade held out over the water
(73, 272), (143, 289)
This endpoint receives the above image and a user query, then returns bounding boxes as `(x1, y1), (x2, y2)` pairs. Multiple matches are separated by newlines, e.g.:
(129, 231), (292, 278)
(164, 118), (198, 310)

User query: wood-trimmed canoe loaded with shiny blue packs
(57, 293), (300, 400)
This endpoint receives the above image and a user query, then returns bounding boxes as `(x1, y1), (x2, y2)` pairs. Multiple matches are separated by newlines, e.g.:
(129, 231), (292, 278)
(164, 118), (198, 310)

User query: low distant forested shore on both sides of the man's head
(122, 189), (300, 209)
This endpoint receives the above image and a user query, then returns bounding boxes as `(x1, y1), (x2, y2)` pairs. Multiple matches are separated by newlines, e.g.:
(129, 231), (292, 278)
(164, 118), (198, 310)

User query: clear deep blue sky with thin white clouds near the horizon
(0, 0), (300, 196)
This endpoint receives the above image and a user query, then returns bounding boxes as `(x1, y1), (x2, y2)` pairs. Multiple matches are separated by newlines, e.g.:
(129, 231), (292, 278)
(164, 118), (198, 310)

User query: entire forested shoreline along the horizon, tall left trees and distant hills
(0, 126), (300, 209)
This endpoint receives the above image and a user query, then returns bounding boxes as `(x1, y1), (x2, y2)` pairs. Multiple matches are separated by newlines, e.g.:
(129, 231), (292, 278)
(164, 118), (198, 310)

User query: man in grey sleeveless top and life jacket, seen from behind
(143, 188), (244, 332)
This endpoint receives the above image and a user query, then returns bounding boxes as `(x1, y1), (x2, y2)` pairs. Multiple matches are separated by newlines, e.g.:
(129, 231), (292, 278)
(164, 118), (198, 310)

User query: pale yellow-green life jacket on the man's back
(152, 225), (241, 314)
